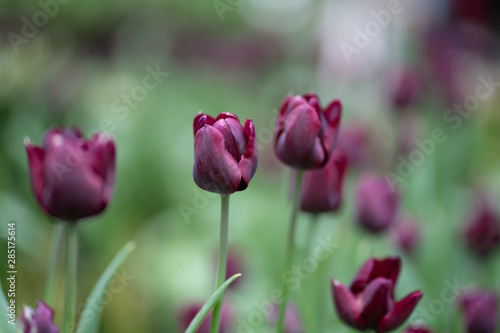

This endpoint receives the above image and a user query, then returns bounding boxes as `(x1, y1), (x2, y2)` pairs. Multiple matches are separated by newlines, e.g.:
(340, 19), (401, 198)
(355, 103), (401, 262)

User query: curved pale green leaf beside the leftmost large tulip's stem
(76, 241), (135, 333)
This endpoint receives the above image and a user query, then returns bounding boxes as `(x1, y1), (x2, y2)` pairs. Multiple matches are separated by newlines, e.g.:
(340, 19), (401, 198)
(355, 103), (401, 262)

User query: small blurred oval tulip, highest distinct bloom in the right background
(389, 68), (421, 110)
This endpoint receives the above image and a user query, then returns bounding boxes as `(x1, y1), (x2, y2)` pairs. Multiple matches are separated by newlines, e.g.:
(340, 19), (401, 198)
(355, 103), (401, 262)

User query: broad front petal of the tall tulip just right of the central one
(277, 101), (326, 169)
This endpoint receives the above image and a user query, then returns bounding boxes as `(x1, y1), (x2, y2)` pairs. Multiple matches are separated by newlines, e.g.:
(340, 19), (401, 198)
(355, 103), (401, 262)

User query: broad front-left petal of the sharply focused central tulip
(193, 126), (241, 194)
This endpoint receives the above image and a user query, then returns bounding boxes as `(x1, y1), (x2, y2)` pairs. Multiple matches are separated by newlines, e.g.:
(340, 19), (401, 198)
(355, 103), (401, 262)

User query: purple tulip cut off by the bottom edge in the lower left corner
(19, 301), (59, 333)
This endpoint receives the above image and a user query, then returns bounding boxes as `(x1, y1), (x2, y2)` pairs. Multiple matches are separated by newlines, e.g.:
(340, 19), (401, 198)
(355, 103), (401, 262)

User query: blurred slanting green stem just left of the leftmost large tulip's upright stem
(43, 222), (64, 307)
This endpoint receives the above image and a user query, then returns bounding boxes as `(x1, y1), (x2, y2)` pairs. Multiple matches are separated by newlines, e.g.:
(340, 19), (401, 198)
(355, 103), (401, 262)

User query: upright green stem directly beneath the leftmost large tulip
(62, 222), (78, 333)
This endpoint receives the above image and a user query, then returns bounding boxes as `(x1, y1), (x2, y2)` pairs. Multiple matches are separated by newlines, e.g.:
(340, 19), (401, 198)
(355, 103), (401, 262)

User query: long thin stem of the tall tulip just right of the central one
(276, 170), (303, 333)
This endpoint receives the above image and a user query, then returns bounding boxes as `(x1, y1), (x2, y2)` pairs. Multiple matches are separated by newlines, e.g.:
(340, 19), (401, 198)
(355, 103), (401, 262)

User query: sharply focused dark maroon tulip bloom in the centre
(193, 112), (257, 194)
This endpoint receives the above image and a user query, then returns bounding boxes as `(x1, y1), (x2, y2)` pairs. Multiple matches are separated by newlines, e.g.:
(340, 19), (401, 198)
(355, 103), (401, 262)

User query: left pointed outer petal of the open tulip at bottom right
(331, 279), (367, 331)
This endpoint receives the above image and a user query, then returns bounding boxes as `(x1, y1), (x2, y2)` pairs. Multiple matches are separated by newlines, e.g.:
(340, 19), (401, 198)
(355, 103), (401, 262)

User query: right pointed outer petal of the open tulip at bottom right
(377, 291), (423, 333)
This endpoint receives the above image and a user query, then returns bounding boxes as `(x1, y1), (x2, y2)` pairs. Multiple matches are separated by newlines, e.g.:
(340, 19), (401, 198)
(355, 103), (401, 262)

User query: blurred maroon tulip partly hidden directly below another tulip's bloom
(301, 148), (347, 214)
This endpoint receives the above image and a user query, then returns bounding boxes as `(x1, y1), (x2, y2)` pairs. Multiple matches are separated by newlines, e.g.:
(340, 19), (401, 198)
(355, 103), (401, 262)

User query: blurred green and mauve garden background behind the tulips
(0, 0), (500, 333)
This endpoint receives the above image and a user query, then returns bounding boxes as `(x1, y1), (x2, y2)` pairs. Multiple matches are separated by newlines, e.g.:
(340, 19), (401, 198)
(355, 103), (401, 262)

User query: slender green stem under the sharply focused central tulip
(210, 195), (229, 333)
